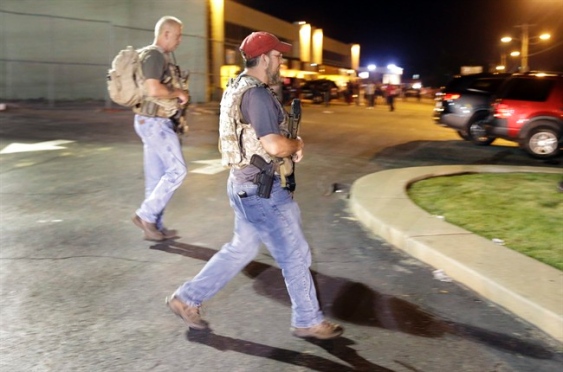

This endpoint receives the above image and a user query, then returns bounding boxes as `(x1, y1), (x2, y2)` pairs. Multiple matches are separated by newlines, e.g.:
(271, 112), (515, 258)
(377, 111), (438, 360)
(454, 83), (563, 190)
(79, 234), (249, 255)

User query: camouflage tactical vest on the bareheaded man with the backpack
(133, 45), (184, 118)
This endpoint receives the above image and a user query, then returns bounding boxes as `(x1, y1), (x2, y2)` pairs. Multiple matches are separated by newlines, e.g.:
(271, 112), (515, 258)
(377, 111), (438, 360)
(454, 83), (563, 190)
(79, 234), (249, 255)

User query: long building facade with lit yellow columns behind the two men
(0, 0), (359, 105)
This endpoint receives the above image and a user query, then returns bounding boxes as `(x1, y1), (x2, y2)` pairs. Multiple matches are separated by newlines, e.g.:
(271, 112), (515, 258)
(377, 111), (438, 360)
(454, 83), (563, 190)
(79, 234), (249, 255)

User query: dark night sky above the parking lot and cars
(235, 0), (563, 85)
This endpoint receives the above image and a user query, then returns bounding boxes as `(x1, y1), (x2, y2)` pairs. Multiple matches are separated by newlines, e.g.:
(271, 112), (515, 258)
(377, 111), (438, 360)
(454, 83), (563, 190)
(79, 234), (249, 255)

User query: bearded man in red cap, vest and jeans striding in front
(167, 32), (343, 339)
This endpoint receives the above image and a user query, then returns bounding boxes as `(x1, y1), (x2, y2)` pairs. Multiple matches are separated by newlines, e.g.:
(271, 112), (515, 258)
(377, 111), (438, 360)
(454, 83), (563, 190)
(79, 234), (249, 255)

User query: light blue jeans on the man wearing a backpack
(135, 115), (187, 230)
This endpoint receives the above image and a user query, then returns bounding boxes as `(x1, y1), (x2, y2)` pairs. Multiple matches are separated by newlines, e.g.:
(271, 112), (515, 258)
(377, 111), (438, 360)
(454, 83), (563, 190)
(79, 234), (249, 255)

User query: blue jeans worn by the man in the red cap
(175, 177), (323, 328)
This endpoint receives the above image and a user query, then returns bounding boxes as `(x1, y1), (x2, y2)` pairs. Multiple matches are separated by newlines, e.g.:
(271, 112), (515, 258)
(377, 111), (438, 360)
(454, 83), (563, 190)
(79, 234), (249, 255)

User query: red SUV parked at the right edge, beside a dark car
(483, 72), (563, 159)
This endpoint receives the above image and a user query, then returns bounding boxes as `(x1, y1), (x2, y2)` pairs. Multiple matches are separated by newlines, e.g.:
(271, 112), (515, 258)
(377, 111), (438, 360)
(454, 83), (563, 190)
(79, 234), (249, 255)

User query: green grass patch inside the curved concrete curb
(408, 173), (563, 271)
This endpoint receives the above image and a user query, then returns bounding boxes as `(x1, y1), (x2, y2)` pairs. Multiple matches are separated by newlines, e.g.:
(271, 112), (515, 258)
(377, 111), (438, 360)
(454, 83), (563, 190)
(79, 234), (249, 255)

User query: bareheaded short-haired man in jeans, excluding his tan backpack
(133, 16), (189, 241)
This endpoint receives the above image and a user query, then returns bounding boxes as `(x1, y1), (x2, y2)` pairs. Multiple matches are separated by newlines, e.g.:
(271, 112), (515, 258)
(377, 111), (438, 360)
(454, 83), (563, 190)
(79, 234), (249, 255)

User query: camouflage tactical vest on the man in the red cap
(219, 75), (291, 170)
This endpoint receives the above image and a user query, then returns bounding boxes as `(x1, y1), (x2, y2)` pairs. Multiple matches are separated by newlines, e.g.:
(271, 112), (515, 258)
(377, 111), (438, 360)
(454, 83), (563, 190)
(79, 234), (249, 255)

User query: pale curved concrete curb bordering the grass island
(350, 165), (563, 342)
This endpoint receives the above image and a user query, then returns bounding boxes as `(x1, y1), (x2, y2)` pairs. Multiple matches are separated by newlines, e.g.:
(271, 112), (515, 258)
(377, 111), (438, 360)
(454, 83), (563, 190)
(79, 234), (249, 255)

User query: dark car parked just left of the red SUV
(433, 73), (511, 145)
